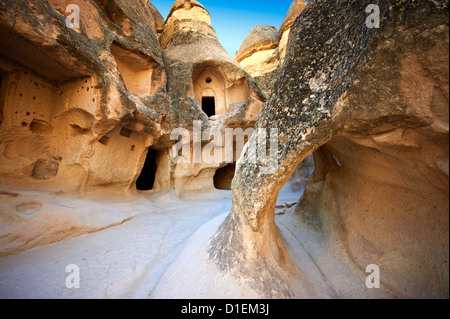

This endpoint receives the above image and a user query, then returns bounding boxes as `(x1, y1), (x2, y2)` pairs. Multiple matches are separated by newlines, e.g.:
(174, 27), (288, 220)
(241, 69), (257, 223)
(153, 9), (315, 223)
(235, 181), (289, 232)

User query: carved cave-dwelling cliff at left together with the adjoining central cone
(0, 0), (266, 198)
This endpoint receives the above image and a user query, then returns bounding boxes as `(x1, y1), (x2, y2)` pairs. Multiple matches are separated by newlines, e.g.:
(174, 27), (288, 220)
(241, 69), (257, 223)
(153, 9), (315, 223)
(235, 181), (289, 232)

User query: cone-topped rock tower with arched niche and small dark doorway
(155, 1), (267, 194)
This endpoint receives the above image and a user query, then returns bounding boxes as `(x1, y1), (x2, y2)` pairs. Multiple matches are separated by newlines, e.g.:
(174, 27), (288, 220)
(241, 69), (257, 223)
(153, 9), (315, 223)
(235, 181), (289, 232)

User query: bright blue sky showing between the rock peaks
(150, 0), (302, 57)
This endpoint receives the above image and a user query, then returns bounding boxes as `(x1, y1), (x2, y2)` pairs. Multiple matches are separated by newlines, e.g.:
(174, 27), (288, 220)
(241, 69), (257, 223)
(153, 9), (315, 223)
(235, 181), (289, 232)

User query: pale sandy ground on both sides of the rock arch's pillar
(0, 187), (385, 298)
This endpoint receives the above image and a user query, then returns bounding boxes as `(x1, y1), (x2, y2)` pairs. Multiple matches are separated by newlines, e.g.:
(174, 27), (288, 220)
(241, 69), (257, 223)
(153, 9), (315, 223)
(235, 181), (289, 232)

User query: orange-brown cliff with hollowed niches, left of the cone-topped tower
(0, 0), (167, 195)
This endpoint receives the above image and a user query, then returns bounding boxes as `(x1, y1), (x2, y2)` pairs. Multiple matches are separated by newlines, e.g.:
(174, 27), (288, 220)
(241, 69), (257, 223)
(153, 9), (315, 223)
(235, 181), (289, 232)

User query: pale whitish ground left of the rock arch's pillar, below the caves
(0, 192), (231, 298)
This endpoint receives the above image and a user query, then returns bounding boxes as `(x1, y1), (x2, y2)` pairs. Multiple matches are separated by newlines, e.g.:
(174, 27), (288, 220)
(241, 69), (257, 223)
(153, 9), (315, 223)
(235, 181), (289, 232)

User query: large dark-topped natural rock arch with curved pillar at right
(209, 0), (449, 297)
